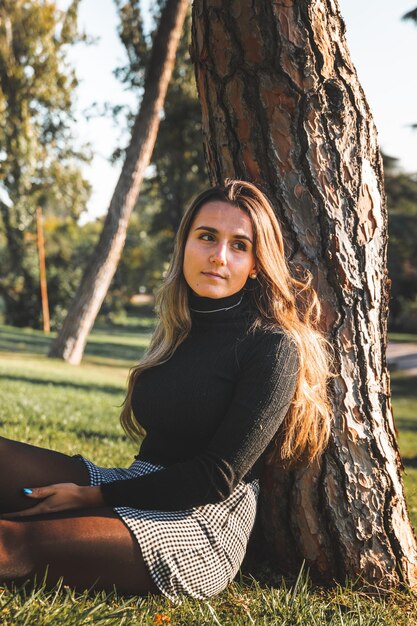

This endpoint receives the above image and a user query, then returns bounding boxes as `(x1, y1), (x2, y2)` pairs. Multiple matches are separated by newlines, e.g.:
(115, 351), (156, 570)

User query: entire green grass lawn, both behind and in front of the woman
(0, 319), (417, 626)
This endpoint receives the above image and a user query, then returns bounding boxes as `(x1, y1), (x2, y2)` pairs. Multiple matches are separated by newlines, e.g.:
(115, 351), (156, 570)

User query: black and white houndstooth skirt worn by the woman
(77, 455), (259, 602)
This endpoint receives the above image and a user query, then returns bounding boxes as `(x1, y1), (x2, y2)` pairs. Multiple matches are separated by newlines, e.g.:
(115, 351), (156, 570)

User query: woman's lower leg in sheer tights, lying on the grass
(0, 508), (159, 595)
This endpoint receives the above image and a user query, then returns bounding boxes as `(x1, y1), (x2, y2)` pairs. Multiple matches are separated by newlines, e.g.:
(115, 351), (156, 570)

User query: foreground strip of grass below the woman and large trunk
(0, 576), (417, 626)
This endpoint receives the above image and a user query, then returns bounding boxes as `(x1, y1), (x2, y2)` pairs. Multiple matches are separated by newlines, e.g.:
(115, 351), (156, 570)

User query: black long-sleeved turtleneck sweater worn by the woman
(101, 290), (298, 511)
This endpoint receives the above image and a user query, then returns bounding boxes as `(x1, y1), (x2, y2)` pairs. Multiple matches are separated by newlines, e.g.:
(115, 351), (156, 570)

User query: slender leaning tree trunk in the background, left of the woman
(49, 0), (188, 365)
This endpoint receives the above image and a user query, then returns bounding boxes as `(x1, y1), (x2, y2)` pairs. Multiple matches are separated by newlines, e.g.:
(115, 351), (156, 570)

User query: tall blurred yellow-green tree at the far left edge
(0, 0), (90, 326)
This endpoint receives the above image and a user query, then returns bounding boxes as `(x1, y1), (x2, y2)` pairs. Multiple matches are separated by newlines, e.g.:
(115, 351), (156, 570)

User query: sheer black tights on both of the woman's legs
(0, 437), (158, 595)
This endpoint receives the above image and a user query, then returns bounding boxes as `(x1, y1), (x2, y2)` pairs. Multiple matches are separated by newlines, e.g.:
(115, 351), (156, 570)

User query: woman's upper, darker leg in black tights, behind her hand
(0, 437), (89, 514)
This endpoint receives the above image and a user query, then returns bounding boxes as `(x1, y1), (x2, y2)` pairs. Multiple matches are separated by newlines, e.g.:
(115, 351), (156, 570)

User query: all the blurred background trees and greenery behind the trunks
(0, 0), (417, 332)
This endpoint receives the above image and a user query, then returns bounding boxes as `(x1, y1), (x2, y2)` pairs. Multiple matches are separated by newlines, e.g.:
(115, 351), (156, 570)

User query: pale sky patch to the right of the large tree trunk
(339, 0), (417, 172)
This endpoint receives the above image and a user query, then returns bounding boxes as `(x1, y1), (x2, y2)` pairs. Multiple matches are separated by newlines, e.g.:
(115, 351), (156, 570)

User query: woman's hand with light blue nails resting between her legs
(1, 483), (104, 519)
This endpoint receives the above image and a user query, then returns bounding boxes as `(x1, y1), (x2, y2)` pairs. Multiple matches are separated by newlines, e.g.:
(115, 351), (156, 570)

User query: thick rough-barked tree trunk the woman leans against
(192, 0), (417, 588)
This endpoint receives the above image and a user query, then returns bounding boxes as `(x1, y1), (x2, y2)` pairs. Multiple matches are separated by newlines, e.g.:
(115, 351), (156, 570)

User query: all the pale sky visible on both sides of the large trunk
(64, 0), (417, 219)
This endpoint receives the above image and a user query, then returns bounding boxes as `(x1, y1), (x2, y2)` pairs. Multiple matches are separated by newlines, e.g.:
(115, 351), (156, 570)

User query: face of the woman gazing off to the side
(183, 200), (256, 298)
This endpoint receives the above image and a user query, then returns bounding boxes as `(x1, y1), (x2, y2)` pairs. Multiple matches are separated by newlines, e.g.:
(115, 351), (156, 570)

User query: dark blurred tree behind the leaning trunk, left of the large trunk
(111, 3), (209, 301)
